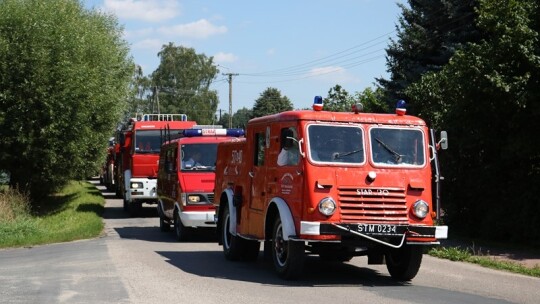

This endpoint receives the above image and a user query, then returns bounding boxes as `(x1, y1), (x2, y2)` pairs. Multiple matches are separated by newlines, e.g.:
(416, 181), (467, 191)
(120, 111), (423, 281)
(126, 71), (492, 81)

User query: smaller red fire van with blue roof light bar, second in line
(157, 126), (244, 241)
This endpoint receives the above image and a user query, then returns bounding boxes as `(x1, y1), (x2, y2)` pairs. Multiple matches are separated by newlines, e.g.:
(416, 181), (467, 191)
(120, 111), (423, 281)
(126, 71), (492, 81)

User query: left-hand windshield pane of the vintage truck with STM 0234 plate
(307, 124), (365, 164)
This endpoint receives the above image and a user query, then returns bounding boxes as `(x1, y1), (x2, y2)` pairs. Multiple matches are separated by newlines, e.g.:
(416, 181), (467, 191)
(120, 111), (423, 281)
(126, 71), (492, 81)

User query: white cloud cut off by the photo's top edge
(103, 0), (180, 22)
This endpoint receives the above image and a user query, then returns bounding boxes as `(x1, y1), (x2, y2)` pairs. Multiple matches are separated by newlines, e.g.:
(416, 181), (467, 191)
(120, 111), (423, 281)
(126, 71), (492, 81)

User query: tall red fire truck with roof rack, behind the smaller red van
(115, 114), (196, 216)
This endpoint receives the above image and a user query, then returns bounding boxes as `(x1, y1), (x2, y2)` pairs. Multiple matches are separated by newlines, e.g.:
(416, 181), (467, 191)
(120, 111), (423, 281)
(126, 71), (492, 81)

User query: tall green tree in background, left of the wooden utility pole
(151, 42), (219, 124)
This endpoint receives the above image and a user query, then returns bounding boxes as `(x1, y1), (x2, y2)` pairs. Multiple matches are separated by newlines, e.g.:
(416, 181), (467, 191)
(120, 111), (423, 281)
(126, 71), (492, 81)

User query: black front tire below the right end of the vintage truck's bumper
(386, 245), (424, 281)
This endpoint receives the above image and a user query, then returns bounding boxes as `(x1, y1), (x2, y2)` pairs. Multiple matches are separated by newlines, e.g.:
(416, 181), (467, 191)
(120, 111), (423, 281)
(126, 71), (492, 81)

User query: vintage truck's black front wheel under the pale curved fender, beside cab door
(272, 216), (305, 280)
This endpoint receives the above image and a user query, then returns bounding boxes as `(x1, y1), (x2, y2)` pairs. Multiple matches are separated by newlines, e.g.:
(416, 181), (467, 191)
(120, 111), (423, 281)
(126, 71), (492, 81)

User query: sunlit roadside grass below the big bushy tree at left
(0, 181), (105, 248)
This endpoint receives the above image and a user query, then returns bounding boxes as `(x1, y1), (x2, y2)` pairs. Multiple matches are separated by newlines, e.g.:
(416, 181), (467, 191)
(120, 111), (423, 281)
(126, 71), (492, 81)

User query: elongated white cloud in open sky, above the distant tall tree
(158, 19), (227, 39)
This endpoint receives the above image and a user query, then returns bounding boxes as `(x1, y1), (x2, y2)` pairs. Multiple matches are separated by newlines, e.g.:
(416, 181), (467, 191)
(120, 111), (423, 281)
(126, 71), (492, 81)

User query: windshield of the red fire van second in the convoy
(180, 143), (217, 172)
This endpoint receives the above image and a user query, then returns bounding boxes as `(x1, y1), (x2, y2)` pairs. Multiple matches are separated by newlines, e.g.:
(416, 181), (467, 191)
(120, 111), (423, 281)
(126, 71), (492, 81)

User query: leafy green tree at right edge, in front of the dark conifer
(407, 0), (540, 245)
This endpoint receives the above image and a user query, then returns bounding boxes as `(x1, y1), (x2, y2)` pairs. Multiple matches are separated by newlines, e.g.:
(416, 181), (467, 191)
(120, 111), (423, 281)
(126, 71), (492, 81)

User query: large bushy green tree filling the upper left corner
(0, 0), (133, 200)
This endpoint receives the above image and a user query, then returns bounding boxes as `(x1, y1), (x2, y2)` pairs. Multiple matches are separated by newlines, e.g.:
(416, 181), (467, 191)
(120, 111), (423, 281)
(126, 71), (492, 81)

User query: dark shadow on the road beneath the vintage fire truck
(157, 251), (402, 287)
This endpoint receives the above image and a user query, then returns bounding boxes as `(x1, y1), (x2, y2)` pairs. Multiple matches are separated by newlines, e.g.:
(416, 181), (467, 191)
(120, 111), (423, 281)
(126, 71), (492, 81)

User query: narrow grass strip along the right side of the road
(428, 247), (540, 277)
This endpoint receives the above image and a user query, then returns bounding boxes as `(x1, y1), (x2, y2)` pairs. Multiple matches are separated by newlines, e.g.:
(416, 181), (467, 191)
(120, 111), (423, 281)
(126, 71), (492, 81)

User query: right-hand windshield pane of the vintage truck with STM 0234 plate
(369, 127), (425, 167)
